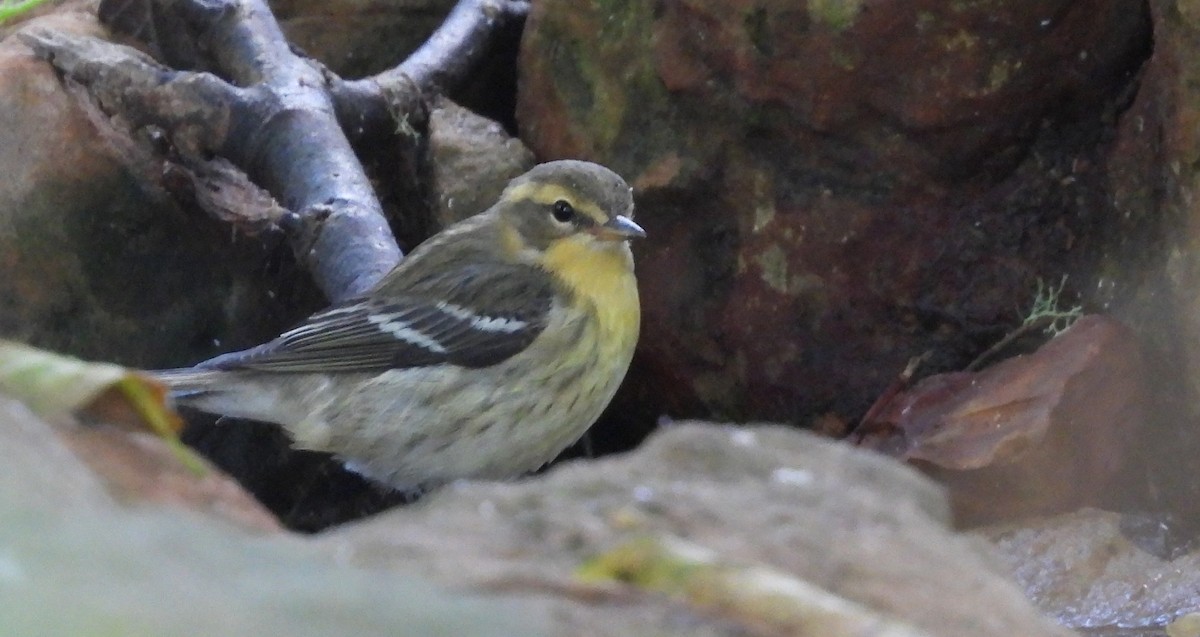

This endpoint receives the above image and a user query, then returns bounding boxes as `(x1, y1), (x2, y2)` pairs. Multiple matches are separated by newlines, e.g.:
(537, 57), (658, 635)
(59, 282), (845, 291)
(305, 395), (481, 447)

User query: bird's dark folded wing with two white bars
(200, 262), (554, 372)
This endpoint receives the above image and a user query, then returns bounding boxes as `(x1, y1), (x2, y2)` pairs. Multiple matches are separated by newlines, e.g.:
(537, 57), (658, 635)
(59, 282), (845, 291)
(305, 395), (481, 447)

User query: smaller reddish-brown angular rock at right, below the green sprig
(859, 316), (1148, 525)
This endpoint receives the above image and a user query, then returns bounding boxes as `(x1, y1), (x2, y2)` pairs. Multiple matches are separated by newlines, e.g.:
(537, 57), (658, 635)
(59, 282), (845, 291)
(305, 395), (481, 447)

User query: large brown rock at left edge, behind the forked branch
(0, 12), (304, 367)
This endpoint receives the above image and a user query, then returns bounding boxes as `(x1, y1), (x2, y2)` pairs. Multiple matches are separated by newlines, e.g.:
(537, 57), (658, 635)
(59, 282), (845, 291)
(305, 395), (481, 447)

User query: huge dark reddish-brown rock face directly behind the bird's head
(517, 0), (1150, 429)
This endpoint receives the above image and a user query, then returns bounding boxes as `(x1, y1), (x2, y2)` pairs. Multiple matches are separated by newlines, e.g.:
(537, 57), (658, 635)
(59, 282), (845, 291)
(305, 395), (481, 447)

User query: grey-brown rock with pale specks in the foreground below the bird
(318, 423), (1067, 636)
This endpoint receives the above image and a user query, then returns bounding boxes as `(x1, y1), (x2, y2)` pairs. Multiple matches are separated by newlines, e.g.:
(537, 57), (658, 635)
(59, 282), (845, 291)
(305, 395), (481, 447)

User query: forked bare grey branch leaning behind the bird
(26, 0), (528, 301)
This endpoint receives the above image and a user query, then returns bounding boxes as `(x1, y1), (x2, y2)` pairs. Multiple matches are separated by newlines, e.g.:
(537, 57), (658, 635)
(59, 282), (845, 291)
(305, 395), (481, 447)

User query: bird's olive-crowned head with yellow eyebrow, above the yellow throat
(500, 161), (634, 248)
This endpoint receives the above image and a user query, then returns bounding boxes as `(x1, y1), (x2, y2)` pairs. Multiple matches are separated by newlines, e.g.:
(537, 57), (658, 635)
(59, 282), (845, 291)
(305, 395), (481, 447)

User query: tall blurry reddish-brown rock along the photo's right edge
(1098, 0), (1200, 518)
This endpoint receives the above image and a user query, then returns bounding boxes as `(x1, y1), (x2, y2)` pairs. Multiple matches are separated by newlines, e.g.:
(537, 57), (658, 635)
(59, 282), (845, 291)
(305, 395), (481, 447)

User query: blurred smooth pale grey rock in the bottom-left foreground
(0, 397), (545, 637)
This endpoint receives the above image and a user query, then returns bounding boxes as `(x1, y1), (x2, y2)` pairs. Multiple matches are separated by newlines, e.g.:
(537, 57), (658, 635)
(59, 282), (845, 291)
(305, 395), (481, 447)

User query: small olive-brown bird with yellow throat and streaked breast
(155, 160), (646, 489)
